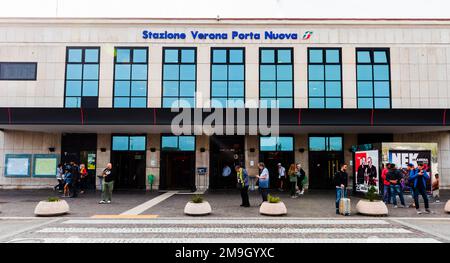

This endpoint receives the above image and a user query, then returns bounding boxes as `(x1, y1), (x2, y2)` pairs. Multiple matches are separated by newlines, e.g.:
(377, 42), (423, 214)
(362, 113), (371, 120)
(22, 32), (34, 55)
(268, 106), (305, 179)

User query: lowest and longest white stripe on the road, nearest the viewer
(10, 236), (441, 244)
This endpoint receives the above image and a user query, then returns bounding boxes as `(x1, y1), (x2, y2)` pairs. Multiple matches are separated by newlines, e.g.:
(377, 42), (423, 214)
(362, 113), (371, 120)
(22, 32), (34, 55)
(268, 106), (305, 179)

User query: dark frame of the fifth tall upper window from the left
(258, 47), (295, 109)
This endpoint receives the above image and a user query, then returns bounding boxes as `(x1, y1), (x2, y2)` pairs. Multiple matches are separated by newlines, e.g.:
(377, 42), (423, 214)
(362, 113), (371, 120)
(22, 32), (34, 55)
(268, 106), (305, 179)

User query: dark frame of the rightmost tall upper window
(355, 47), (392, 109)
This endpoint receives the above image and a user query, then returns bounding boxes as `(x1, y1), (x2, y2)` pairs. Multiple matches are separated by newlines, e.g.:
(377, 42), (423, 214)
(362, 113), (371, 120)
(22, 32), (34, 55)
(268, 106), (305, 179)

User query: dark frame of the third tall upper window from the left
(161, 46), (198, 108)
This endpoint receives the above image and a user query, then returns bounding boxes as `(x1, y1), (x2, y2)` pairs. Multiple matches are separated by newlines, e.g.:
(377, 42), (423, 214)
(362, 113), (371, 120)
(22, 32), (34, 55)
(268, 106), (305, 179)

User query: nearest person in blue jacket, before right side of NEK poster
(409, 163), (431, 215)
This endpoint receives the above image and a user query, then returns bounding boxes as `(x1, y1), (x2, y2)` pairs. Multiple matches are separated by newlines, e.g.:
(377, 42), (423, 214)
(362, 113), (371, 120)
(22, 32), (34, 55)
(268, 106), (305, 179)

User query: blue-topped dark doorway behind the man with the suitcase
(308, 136), (344, 189)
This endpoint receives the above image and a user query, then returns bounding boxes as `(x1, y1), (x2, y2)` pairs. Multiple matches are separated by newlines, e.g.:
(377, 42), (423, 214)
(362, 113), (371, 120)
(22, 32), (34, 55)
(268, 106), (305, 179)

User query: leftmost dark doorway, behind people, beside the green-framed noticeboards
(61, 133), (97, 189)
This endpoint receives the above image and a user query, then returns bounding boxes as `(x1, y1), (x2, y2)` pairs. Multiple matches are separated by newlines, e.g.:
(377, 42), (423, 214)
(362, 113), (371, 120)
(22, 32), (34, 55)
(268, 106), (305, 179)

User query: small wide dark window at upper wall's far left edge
(0, 62), (37, 80)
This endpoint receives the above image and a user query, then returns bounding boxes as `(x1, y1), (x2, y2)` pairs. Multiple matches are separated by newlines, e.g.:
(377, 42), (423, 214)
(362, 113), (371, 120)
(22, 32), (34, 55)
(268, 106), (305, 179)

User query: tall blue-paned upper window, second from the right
(308, 48), (342, 108)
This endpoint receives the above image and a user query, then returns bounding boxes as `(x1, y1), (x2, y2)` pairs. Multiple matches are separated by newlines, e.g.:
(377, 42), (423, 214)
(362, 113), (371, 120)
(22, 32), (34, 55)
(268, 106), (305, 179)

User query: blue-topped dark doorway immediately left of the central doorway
(160, 136), (196, 191)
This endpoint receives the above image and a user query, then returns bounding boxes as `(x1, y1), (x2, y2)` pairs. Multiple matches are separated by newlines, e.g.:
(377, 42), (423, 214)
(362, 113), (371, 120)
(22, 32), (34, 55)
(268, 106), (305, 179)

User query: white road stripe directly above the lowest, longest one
(38, 227), (411, 234)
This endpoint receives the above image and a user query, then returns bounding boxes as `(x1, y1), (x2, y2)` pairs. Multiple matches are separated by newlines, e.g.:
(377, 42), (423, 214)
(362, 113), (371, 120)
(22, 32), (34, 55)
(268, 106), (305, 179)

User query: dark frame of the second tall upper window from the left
(112, 46), (150, 109)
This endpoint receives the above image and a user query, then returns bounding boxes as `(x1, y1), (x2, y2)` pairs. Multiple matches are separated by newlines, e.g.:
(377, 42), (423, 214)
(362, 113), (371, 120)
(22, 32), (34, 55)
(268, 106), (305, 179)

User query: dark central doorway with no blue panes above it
(209, 136), (245, 189)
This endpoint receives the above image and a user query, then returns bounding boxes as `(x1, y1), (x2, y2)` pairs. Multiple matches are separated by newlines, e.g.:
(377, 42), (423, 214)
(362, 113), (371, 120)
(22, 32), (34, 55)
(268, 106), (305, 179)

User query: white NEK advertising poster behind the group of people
(389, 150), (432, 192)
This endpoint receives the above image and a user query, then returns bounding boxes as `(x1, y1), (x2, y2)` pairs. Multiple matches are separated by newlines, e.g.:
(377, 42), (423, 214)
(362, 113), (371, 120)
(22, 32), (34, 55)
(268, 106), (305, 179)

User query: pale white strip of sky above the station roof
(0, 0), (450, 18)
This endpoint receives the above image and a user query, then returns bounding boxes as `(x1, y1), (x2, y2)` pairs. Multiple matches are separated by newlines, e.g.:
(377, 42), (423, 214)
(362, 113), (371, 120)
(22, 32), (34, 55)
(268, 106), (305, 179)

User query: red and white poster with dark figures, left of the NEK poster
(355, 151), (379, 193)
